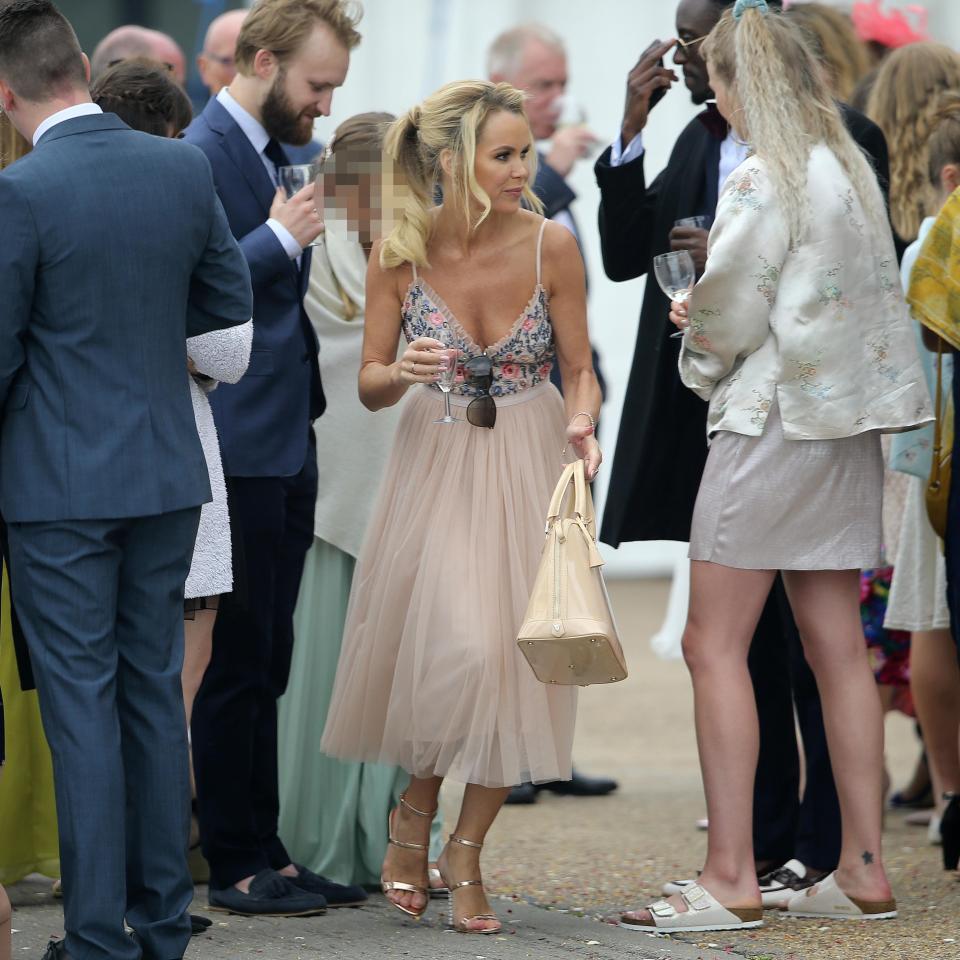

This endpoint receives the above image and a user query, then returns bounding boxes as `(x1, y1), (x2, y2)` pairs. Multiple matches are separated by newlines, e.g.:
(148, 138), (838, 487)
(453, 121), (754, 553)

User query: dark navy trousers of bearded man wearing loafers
(192, 438), (320, 890)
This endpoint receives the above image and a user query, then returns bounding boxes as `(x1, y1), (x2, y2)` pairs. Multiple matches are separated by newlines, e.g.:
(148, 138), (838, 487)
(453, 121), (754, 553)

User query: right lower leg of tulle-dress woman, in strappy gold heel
(437, 783), (510, 930)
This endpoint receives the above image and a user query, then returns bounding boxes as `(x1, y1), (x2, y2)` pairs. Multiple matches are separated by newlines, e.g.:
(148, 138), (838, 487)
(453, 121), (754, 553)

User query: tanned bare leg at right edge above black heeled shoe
(910, 630), (960, 812)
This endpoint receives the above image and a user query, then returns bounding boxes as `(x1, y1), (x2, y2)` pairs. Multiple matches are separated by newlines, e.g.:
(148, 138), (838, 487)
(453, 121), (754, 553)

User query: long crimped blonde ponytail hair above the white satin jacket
(703, 7), (888, 247)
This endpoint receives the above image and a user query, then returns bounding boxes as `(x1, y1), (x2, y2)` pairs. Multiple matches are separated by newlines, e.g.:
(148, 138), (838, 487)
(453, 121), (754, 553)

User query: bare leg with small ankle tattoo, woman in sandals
(783, 570), (892, 901)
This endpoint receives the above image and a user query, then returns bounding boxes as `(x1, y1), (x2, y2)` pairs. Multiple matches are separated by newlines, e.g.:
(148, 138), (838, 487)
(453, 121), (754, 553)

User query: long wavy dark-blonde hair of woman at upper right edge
(867, 41), (960, 240)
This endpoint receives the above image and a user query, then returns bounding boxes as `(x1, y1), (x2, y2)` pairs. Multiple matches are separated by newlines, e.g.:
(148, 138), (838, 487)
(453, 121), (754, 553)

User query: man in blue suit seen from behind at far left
(0, 0), (252, 960)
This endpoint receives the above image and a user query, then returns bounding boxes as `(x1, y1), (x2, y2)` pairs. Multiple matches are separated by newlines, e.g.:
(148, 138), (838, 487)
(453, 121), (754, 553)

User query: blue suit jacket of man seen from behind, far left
(0, 114), (252, 523)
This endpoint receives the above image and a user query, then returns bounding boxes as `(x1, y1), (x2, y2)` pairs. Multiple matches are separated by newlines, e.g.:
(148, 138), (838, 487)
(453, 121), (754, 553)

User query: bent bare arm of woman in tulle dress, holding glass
(359, 240), (443, 410)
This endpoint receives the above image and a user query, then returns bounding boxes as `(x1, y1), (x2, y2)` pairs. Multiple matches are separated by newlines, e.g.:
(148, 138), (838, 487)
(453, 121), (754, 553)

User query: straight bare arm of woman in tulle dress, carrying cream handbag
(543, 223), (603, 480)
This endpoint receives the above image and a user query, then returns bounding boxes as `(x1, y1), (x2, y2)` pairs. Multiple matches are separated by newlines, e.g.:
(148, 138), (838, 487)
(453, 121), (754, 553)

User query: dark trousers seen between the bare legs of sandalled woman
(748, 575), (840, 870)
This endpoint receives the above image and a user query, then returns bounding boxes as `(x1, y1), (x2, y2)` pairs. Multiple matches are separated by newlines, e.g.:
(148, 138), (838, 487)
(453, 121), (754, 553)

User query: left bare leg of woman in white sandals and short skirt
(627, 560), (775, 923)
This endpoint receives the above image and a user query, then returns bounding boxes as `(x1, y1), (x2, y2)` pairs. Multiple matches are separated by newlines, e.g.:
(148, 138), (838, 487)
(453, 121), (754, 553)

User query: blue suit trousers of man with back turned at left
(8, 507), (200, 960)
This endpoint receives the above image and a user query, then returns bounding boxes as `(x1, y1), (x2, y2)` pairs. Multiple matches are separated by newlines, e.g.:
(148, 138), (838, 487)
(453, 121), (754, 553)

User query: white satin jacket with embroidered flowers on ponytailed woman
(680, 144), (932, 440)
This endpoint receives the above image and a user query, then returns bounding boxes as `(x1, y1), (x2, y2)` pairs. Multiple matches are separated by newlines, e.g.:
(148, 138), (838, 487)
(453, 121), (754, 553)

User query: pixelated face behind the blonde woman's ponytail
(318, 146), (408, 250)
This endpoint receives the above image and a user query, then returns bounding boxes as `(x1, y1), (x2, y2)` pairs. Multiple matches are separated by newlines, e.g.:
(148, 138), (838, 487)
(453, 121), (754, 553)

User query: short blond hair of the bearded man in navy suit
(234, 0), (363, 76)
